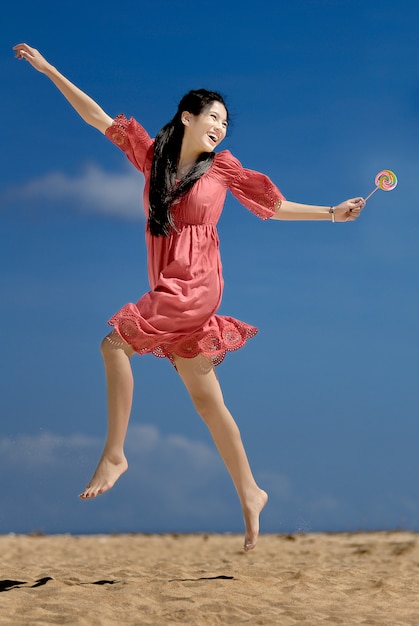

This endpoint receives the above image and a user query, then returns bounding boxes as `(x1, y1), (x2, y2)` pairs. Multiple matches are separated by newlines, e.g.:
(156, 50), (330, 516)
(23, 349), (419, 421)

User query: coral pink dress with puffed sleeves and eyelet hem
(106, 115), (284, 365)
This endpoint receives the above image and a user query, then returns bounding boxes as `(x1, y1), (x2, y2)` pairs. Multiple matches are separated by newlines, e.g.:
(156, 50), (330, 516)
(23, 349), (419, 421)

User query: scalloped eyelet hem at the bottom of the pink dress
(108, 314), (258, 365)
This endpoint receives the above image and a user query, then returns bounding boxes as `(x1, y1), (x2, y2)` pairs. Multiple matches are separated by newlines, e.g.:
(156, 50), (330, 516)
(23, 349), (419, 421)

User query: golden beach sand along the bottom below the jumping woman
(0, 532), (419, 626)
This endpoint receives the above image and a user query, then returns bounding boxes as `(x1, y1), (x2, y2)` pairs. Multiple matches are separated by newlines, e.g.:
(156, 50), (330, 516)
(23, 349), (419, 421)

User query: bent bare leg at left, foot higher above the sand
(80, 331), (134, 499)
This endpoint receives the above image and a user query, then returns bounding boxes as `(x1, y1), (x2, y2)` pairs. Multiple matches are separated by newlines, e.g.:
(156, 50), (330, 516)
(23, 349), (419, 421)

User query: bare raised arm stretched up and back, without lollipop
(13, 43), (113, 133)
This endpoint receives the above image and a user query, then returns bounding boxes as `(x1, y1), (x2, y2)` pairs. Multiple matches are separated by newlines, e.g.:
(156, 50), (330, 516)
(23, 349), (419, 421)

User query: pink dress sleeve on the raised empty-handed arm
(105, 113), (154, 173)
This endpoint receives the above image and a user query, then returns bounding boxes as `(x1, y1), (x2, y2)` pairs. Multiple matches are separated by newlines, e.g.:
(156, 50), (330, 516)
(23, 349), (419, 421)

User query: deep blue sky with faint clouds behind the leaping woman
(0, 0), (419, 532)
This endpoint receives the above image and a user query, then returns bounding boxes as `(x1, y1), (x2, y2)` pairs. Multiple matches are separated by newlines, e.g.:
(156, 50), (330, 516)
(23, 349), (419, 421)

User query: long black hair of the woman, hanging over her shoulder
(148, 89), (226, 237)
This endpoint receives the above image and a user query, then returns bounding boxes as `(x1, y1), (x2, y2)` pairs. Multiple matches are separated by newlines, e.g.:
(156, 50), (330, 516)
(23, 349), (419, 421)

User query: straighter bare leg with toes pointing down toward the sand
(175, 356), (268, 552)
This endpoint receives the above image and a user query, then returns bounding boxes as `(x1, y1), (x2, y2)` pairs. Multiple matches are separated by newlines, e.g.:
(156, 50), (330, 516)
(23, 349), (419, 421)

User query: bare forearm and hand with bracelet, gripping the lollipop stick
(271, 198), (365, 222)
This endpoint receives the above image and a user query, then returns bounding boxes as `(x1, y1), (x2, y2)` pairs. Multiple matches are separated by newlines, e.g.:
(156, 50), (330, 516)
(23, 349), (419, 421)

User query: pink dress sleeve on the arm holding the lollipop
(218, 150), (285, 220)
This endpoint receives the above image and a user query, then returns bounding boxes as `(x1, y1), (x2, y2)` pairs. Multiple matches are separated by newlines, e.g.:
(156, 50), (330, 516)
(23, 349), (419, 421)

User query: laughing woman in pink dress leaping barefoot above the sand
(14, 44), (365, 551)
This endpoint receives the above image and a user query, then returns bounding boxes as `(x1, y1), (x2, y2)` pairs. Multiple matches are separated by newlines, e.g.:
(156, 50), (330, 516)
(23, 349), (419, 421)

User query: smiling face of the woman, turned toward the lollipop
(182, 101), (228, 155)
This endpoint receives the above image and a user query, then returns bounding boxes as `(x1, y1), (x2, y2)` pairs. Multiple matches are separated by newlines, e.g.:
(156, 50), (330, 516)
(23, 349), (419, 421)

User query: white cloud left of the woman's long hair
(3, 164), (144, 219)
